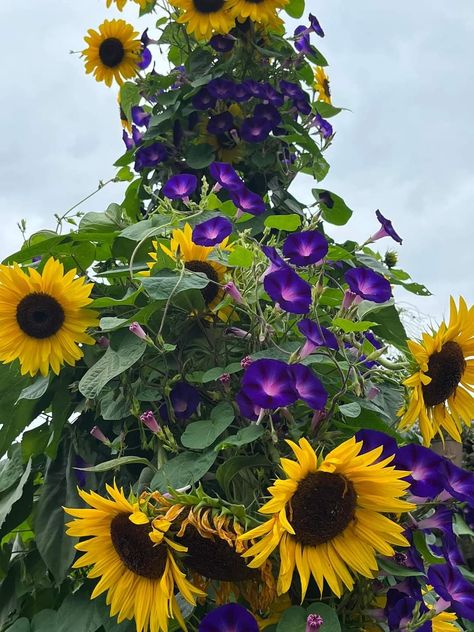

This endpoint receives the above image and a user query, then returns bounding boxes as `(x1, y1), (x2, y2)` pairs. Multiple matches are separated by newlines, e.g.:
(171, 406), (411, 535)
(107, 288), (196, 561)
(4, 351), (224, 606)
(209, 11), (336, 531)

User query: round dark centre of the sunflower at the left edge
(16, 292), (64, 339)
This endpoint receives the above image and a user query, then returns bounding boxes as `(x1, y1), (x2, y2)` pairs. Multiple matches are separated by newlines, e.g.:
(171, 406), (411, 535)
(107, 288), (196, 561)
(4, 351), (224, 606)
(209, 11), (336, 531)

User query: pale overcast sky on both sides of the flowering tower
(0, 0), (474, 330)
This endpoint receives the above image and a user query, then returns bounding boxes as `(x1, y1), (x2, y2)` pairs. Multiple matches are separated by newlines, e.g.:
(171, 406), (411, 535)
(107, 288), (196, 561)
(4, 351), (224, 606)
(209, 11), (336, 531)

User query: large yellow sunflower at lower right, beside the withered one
(240, 437), (415, 599)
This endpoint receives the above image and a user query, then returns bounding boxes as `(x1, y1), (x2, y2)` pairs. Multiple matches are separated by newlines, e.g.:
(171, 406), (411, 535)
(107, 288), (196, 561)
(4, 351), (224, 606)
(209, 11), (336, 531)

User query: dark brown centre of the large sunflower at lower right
(288, 472), (357, 546)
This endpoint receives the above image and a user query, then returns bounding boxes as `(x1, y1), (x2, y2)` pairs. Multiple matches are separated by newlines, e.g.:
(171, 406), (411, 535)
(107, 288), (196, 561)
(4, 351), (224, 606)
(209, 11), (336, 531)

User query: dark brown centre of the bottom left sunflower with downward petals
(110, 514), (167, 579)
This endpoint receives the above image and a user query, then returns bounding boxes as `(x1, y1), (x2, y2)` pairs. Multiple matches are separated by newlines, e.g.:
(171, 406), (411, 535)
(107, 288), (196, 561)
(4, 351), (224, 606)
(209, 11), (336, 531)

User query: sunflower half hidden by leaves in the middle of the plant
(148, 223), (233, 321)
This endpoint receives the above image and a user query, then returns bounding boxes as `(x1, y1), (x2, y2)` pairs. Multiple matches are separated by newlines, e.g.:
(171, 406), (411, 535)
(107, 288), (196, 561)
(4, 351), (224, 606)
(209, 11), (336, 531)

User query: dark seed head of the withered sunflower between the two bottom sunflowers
(179, 525), (256, 582)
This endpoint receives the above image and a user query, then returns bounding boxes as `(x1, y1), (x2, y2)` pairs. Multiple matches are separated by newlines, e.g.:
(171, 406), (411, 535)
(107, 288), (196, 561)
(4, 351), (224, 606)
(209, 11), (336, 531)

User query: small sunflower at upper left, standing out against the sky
(82, 20), (142, 87)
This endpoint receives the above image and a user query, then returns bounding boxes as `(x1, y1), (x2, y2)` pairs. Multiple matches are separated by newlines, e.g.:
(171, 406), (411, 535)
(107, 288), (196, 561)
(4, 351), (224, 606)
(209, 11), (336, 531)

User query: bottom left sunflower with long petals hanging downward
(64, 483), (202, 632)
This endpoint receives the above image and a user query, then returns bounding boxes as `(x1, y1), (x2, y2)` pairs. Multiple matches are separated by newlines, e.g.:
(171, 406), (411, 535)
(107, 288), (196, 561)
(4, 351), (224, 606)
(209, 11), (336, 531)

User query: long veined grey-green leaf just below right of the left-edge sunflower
(79, 331), (146, 399)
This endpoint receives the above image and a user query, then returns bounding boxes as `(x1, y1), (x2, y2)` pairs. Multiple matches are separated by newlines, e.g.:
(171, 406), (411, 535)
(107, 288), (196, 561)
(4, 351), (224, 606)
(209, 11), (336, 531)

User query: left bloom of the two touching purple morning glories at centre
(241, 358), (298, 408)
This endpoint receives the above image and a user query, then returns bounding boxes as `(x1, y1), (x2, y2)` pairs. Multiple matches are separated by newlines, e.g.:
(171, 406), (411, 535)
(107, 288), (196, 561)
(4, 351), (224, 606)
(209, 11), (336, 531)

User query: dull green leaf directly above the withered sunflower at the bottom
(150, 450), (217, 492)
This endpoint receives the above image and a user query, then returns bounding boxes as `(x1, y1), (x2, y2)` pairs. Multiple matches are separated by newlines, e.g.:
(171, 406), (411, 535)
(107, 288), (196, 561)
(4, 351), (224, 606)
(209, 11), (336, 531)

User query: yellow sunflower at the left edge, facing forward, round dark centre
(0, 258), (98, 376)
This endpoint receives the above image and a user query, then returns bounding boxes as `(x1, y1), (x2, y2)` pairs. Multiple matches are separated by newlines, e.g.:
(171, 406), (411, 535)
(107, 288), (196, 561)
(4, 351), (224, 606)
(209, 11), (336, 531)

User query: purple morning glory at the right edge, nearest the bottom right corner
(428, 564), (474, 621)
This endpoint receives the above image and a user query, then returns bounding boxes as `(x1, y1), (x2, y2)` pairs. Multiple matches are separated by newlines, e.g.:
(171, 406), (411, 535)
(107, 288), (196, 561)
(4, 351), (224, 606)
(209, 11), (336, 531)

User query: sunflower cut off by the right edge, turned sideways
(398, 297), (474, 446)
